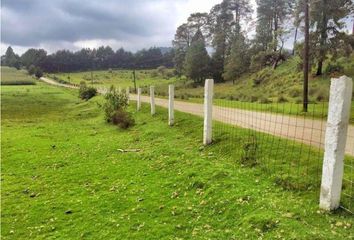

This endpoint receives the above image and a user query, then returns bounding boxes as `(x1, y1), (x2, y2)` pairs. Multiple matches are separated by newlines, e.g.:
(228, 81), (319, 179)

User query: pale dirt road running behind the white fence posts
(41, 78), (354, 156)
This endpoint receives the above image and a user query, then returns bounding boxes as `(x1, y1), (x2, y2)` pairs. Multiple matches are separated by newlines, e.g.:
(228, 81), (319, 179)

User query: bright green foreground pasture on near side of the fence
(1, 84), (354, 239)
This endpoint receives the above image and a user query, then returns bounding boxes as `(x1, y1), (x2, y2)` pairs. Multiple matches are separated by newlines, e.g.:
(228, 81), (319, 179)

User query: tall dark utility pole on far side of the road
(303, 0), (310, 112)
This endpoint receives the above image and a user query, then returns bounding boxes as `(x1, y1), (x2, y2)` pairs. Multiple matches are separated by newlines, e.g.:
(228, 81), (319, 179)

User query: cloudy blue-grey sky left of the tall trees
(1, 0), (225, 54)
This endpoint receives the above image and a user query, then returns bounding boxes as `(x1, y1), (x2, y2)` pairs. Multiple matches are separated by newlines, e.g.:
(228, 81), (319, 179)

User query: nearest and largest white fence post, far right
(320, 76), (353, 210)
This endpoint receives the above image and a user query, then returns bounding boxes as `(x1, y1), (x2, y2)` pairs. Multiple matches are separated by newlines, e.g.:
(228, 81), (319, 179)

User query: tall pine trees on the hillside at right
(173, 0), (354, 83)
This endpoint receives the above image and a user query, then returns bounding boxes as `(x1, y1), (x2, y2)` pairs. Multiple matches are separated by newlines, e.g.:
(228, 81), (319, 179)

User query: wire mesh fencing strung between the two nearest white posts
(213, 99), (354, 213)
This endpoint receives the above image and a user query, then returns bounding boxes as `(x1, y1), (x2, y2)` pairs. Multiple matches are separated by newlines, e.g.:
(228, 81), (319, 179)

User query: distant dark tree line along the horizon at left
(1, 46), (174, 73)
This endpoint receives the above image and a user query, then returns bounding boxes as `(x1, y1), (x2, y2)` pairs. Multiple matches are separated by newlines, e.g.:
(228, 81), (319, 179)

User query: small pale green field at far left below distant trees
(1, 66), (36, 85)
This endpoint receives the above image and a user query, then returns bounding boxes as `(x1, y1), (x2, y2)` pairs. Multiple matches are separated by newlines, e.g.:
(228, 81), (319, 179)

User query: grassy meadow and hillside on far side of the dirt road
(49, 55), (354, 123)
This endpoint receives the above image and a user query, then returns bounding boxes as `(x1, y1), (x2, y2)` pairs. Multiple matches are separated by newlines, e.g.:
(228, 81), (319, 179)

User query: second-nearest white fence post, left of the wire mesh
(203, 79), (214, 145)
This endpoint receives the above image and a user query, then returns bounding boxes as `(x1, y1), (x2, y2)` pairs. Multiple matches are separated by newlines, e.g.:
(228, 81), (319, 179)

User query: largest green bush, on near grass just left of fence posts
(103, 86), (135, 129)
